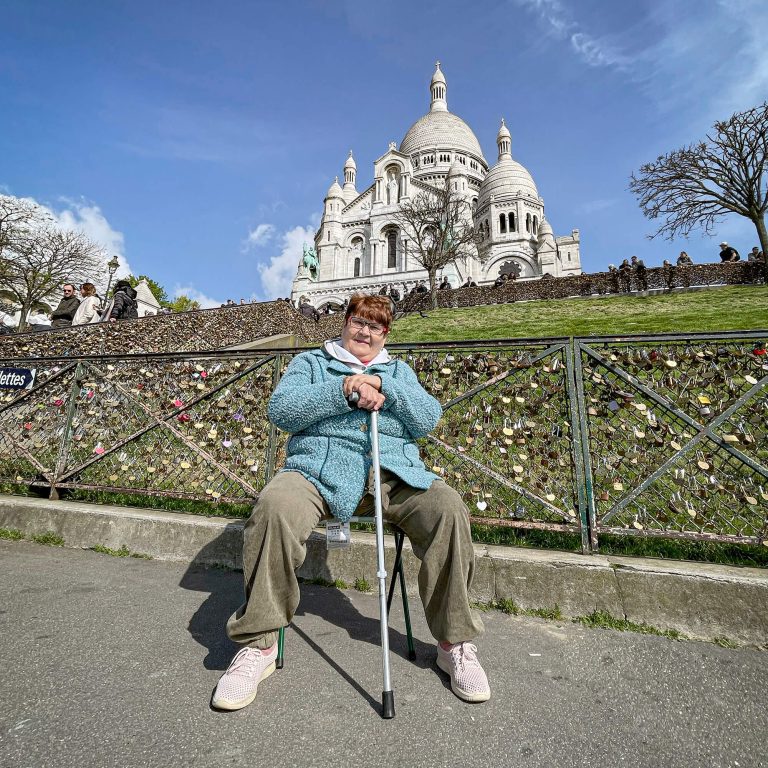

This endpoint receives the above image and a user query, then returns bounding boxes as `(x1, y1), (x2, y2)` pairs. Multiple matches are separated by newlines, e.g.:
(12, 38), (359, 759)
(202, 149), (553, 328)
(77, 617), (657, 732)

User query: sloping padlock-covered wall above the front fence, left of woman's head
(0, 301), (341, 360)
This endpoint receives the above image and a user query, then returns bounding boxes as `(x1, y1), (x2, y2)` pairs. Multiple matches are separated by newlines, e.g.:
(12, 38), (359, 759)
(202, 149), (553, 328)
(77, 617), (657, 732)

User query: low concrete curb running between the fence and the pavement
(0, 496), (768, 646)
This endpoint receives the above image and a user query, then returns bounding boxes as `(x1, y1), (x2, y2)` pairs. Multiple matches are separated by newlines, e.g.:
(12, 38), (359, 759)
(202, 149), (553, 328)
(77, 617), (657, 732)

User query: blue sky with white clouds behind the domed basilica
(0, 0), (768, 306)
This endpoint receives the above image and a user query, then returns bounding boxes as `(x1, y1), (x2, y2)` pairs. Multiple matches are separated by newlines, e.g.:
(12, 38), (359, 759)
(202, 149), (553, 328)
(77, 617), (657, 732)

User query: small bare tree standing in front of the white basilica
(393, 181), (478, 309)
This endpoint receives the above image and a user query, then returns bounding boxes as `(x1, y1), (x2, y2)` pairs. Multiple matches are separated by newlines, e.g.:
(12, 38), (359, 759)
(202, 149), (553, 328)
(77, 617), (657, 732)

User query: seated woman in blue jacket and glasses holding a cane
(212, 295), (491, 710)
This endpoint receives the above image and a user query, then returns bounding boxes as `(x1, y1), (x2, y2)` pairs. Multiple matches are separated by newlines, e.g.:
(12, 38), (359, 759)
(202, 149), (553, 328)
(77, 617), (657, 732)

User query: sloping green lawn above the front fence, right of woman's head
(389, 285), (768, 343)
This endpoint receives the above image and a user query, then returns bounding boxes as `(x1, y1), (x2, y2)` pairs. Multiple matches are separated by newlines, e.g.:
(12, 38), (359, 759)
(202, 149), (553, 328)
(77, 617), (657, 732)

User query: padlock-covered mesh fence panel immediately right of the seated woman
(390, 341), (580, 531)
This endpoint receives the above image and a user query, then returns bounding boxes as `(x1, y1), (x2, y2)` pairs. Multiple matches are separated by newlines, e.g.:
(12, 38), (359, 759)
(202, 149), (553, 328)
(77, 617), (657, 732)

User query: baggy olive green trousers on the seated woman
(227, 470), (483, 649)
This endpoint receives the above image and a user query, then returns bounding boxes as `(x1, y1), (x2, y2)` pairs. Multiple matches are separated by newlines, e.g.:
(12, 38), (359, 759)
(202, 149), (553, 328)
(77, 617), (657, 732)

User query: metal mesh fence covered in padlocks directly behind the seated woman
(0, 332), (768, 551)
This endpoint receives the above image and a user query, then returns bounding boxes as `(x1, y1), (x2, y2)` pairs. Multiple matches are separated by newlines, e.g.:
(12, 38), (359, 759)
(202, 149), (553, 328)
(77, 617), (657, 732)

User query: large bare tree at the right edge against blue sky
(629, 102), (768, 279)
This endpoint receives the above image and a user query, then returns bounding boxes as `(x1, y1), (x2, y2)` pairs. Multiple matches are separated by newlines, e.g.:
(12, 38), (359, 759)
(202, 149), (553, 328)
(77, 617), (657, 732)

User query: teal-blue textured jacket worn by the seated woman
(267, 349), (442, 521)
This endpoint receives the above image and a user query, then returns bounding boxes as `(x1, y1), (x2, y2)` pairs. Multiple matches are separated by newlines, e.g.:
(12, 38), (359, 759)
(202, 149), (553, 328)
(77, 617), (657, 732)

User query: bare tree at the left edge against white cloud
(0, 196), (105, 331)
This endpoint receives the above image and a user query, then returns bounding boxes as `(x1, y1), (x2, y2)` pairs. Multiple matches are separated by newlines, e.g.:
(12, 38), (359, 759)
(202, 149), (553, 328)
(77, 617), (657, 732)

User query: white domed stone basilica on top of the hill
(291, 62), (581, 309)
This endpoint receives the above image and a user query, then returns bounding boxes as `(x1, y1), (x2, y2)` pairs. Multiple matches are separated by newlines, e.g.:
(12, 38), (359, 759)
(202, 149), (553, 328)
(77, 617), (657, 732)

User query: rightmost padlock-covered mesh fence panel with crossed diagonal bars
(577, 335), (768, 545)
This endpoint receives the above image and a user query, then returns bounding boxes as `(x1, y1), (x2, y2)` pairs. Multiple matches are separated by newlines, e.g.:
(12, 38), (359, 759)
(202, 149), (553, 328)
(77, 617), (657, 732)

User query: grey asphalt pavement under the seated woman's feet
(0, 541), (768, 768)
